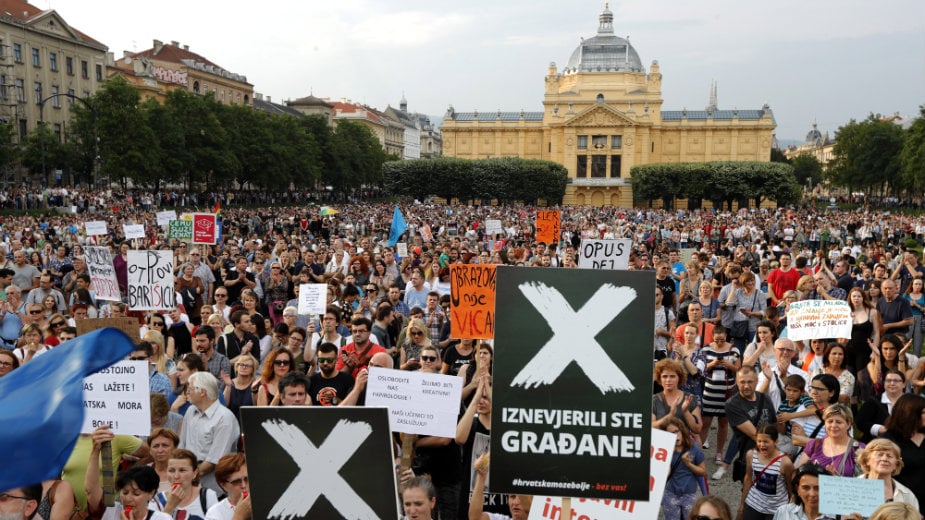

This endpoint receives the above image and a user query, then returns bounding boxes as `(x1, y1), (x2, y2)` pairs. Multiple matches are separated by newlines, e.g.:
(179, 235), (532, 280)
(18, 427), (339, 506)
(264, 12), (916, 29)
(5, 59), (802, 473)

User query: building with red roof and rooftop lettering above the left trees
(108, 40), (254, 106)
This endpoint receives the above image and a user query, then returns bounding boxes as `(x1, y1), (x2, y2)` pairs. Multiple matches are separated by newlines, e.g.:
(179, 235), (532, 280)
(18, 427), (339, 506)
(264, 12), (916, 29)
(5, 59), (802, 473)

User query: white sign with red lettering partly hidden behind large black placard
(529, 428), (678, 520)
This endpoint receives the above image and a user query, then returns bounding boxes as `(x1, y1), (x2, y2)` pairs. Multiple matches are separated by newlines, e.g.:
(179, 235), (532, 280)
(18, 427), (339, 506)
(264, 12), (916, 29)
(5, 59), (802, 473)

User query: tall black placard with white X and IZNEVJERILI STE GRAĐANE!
(490, 267), (655, 500)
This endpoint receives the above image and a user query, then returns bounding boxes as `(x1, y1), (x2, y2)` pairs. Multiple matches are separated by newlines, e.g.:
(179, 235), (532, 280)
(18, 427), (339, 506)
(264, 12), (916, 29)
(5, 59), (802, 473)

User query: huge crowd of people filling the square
(0, 196), (925, 520)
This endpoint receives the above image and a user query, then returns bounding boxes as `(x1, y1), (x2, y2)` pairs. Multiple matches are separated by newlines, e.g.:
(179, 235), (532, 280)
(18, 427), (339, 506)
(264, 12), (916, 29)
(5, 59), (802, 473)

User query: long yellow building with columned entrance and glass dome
(440, 6), (776, 207)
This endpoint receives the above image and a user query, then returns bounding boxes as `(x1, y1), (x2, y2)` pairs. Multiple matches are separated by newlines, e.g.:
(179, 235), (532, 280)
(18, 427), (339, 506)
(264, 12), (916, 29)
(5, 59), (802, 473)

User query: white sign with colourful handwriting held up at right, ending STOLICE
(787, 300), (854, 341)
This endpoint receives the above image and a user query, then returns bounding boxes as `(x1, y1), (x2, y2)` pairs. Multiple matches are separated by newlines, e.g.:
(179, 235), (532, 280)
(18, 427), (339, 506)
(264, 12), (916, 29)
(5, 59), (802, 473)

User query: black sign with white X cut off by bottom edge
(241, 406), (398, 520)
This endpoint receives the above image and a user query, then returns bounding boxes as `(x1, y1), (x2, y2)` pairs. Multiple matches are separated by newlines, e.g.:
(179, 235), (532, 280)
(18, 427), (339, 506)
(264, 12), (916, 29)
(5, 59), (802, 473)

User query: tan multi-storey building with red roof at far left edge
(0, 0), (108, 142)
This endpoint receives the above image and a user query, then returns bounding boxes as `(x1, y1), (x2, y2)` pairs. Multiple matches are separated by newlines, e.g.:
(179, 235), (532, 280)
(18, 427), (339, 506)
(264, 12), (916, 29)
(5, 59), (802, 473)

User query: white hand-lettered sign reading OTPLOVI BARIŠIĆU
(128, 250), (177, 311)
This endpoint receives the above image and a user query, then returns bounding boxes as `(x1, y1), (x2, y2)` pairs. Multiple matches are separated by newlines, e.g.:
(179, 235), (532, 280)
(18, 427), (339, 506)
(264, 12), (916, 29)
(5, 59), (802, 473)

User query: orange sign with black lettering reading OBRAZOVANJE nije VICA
(450, 264), (497, 339)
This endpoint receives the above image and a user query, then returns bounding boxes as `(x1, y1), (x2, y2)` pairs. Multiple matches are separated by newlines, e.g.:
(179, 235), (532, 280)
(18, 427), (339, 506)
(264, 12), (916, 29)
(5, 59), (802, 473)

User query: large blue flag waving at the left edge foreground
(0, 328), (135, 490)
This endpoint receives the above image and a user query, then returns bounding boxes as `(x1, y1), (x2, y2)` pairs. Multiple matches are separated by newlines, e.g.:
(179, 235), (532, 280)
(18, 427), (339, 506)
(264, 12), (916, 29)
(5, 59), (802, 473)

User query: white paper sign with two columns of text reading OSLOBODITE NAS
(366, 367), (463, 437)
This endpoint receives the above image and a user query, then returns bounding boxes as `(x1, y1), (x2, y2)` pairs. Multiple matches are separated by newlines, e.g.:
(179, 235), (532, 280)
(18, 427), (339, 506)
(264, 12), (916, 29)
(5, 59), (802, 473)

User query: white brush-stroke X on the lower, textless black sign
(262, 419), (379, 519)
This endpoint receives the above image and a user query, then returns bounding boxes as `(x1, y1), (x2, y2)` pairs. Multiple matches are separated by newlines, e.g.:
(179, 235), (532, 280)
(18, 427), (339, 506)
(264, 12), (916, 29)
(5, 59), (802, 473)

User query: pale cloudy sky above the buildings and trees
(47, 0), (925, 141)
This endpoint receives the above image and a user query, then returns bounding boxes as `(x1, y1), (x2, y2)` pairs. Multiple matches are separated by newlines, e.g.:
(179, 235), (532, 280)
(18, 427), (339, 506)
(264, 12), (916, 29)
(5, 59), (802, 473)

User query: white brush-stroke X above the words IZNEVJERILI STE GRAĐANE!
(511, 282), (636, 394)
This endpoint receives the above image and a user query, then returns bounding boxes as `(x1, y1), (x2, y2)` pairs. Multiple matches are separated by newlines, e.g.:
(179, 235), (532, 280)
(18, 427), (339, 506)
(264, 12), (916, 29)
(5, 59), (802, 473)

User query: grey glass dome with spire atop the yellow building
(563, 4), (645, 74)
